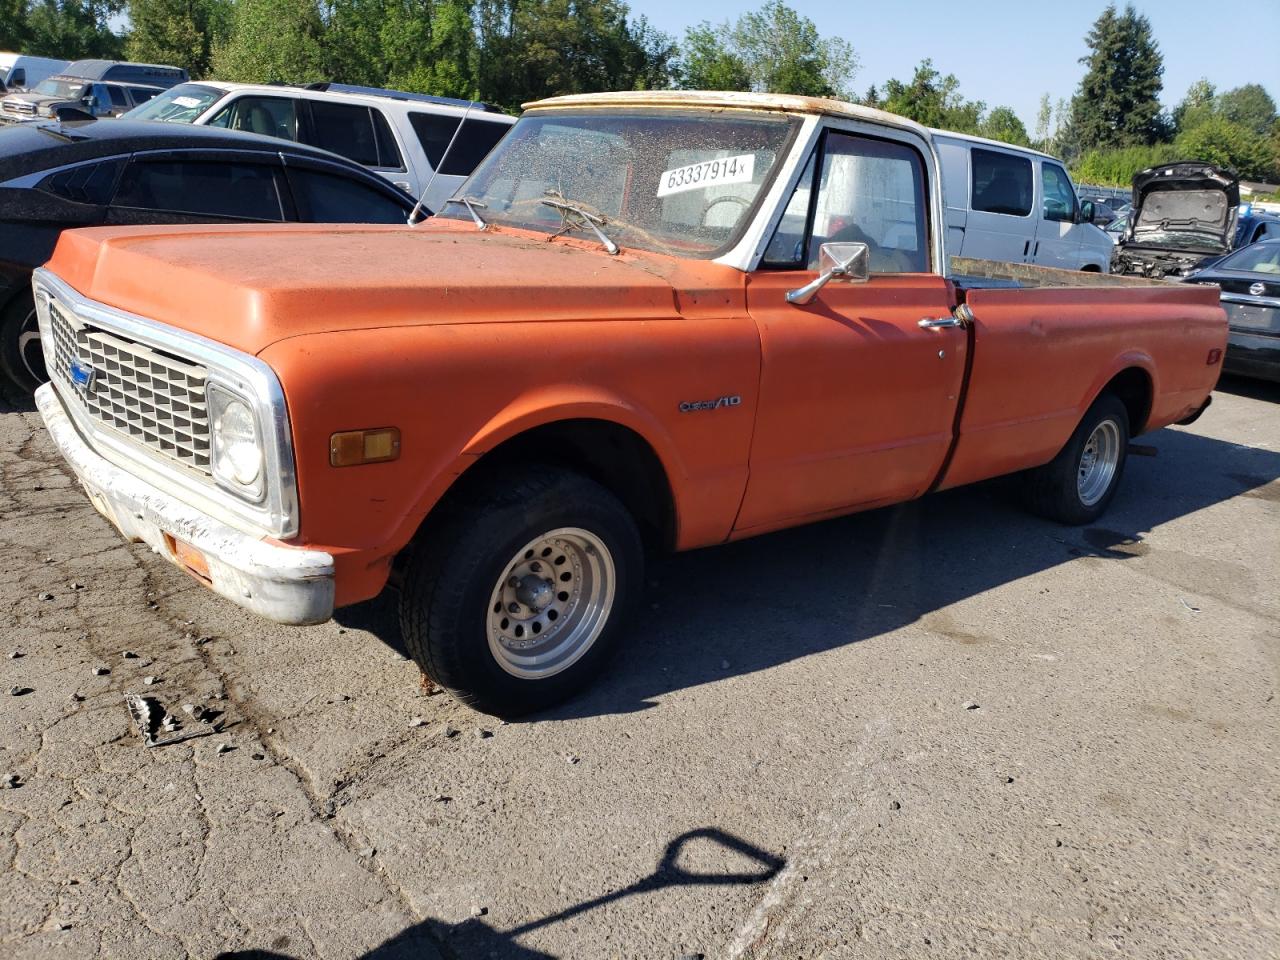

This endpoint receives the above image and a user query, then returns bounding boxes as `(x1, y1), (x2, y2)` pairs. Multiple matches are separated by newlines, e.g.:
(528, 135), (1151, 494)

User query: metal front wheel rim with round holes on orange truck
(486, 526), (617, 680)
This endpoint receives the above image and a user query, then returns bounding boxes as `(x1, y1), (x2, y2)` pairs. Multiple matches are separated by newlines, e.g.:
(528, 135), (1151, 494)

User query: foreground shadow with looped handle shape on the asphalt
(214, 827), (786, 960)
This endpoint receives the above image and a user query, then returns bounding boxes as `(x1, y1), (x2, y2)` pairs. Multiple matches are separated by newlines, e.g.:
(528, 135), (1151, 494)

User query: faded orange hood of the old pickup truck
(47, 220), (744, 353)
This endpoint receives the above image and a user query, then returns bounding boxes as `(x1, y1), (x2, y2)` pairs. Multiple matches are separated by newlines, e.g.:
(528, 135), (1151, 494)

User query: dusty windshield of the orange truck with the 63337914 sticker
(439, 110), (797, 257)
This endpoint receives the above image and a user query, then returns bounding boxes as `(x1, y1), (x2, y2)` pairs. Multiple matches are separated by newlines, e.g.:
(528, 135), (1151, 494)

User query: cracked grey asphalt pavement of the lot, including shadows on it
(0, 380), (1280, 960)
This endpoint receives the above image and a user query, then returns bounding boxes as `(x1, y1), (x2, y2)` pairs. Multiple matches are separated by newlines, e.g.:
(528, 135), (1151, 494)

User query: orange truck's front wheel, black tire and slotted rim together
(399, 467), (644, 717)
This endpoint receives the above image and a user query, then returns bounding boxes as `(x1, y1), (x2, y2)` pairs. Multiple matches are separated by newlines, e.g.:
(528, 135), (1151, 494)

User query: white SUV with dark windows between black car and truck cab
(125, 81), (516, 211)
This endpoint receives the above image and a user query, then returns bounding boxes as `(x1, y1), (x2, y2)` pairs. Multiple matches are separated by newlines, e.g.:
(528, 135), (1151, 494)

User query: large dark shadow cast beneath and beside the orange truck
(338, 424), (1280, 719)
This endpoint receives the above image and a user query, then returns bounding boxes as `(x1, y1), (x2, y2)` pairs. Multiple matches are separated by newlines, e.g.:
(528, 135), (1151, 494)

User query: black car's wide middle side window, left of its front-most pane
(114, 160), (284, 220)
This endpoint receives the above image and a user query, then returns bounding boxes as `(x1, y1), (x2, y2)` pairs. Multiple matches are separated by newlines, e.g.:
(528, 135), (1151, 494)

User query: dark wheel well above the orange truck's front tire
(447, 420), (676, 550)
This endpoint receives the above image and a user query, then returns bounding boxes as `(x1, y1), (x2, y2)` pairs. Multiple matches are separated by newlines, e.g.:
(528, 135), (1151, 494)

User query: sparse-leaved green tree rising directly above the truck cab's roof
(680, 0), (858, 100)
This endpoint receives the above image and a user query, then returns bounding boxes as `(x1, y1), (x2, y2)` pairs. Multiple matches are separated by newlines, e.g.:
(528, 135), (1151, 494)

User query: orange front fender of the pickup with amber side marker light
(261, 312), (759, 605)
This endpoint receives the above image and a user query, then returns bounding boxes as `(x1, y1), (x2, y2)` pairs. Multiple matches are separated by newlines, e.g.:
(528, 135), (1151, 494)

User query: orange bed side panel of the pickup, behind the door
(940, 277), (1226, 489)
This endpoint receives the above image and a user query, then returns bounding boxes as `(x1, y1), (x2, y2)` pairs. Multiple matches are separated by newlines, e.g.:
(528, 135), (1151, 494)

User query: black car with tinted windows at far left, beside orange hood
(0, 120), (413, 392)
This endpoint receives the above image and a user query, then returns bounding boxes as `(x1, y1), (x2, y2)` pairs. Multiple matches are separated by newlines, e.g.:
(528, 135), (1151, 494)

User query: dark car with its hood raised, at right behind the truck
(1111, 161), (1240, 278)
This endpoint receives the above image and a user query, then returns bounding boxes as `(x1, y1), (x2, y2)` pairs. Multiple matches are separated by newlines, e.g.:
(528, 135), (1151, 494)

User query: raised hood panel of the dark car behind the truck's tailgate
(1123, 163), (1240, 255)
